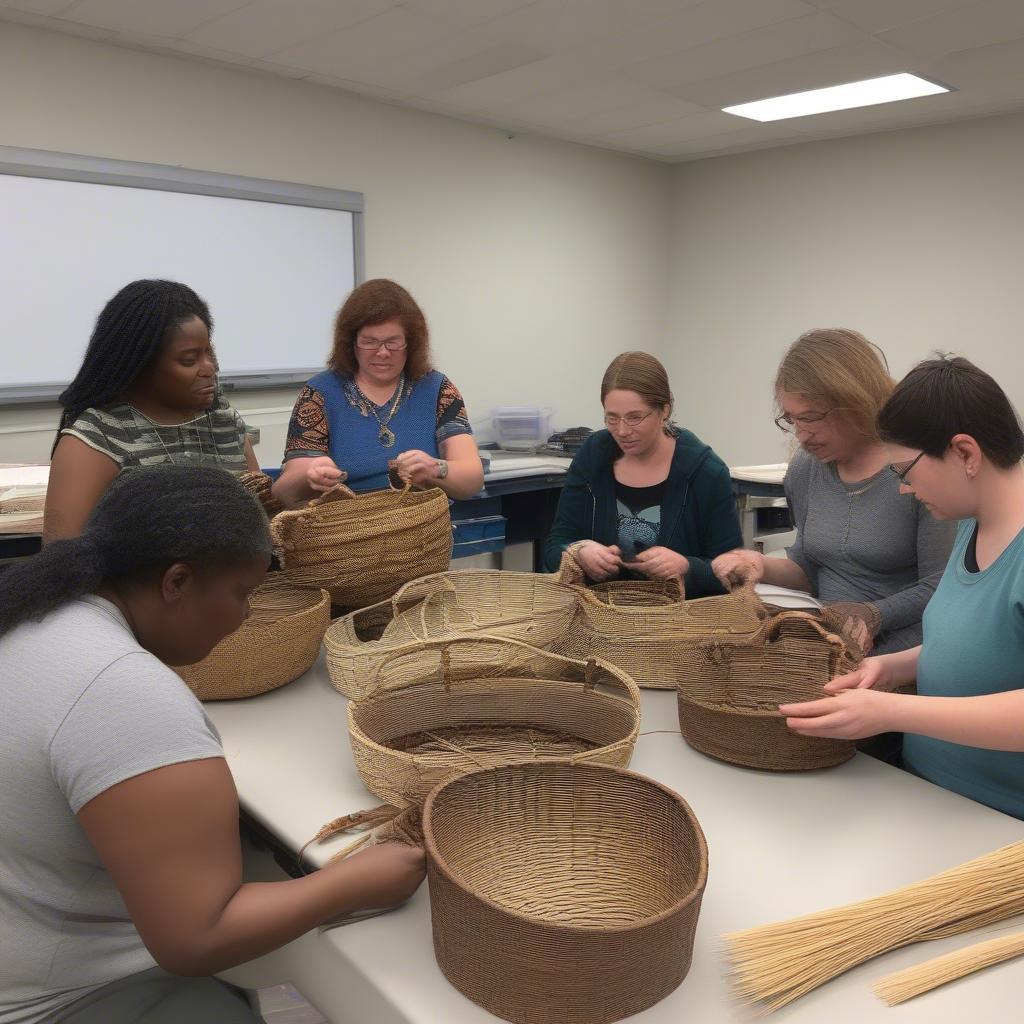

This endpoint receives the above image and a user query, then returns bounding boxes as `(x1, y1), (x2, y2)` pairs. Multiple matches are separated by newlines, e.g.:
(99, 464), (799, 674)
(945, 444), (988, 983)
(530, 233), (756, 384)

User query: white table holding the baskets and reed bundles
(207, 663), (1024, 1024)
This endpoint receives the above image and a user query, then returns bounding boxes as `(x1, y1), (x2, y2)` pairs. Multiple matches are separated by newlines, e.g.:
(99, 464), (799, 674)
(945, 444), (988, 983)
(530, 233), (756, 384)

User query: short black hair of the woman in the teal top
(878, 355), (1024, 469)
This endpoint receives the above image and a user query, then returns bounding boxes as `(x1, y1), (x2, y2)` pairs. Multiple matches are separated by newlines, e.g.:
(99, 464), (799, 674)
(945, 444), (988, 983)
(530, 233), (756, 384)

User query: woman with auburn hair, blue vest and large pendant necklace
(273, 279), (483, 505)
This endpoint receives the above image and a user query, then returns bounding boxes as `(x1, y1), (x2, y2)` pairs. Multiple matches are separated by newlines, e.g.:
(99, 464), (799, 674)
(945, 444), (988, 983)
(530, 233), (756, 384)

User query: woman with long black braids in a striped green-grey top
(43, 281), (259, 543)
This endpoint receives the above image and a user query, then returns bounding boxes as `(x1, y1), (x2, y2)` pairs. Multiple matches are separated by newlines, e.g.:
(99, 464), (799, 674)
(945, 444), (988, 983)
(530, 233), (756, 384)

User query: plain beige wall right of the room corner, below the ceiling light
(667, 109), (1024, 465)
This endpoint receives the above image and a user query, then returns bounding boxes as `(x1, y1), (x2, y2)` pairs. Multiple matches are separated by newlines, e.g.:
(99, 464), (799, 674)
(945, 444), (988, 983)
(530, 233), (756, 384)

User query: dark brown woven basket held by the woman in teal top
(678, 611), (861, 771)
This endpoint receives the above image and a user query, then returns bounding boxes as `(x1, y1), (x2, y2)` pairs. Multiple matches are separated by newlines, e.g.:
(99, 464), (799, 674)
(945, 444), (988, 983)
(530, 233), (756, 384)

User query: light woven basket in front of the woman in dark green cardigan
(554, 552), (767, 690)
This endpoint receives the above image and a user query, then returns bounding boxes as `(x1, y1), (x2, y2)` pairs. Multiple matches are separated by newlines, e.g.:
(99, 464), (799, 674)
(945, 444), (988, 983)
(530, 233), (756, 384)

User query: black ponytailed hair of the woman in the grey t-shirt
(0, 464), (270, 637)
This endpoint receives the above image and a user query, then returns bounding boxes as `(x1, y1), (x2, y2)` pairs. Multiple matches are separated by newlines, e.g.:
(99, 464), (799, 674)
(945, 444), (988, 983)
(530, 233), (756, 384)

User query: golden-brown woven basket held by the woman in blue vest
(270, 483), (452, 609)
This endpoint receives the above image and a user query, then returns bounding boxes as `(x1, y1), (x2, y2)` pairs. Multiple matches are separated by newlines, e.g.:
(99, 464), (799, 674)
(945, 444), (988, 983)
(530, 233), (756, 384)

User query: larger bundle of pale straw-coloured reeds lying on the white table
(725, 842), (1024, 1012)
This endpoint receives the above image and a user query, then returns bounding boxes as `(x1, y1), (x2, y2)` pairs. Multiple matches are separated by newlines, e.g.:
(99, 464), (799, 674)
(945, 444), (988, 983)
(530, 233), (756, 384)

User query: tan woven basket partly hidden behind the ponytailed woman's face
(174, 580), (331, 700)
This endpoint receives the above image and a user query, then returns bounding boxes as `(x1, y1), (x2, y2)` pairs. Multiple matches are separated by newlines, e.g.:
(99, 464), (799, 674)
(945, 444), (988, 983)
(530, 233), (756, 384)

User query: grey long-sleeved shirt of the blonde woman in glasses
(784, 452), (955, 654)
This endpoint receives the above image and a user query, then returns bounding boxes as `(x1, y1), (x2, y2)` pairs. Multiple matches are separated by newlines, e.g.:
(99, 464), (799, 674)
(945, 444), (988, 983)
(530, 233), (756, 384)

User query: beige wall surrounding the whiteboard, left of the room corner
(0, 25), (672, 464)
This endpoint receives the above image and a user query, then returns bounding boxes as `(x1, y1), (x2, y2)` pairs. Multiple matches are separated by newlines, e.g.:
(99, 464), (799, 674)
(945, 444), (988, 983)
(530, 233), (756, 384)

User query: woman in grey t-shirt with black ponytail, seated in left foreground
(0, 465), (424, 1024)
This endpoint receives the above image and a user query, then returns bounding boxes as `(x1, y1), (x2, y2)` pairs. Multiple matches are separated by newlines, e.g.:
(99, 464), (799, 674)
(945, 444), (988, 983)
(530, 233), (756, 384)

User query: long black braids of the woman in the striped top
(54, 281), (213, 438)
